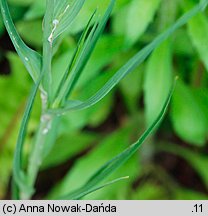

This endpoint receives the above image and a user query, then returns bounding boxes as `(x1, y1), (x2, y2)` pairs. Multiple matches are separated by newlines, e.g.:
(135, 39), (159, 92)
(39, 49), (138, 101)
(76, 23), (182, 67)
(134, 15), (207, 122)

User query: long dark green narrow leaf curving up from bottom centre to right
(59, 80), (175, 199)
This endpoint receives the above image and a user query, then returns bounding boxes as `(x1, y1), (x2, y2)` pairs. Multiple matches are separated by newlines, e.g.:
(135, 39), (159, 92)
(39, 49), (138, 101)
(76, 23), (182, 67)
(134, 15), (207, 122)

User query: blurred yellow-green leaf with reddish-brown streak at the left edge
(0, 53), (31, 199)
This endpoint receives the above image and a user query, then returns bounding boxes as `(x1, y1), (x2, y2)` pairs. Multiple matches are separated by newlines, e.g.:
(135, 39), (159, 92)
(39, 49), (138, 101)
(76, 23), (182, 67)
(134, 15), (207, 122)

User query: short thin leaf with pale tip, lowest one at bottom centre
(60, 176), (129, 200)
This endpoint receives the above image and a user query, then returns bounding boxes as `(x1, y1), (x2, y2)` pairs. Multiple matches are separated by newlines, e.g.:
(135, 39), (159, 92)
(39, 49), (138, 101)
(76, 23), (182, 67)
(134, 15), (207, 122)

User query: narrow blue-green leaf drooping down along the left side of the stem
(13, 76), (42, 196)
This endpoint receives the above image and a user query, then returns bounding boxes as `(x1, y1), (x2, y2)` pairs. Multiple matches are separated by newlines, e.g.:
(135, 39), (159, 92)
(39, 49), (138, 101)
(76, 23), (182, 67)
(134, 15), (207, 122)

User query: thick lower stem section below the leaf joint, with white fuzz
(23, 112), (59, 199)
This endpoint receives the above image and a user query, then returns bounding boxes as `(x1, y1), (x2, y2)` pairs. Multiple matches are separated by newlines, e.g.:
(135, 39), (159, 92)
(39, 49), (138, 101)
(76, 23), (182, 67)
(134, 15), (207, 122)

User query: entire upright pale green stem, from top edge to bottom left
(20, 0), (58, 199)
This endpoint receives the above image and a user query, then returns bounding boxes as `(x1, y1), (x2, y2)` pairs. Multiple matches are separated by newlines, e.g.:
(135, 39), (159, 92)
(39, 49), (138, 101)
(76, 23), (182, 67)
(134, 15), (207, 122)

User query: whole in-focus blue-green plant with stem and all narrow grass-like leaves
(0, 0), (208, 199)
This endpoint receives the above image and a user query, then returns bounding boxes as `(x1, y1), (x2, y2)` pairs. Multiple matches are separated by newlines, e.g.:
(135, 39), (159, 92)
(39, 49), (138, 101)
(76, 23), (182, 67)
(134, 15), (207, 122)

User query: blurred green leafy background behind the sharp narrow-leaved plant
(0, 0), (208, 199)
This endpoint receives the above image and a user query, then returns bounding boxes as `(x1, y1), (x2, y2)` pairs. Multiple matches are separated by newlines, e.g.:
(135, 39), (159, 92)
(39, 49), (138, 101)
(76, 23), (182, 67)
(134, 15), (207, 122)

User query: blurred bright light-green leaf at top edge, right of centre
(112, 0), (161, 48)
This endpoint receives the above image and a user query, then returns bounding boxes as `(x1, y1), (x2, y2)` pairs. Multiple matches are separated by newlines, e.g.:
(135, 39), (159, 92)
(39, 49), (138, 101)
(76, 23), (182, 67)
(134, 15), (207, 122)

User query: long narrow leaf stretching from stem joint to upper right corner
(51, 1), (208, 114)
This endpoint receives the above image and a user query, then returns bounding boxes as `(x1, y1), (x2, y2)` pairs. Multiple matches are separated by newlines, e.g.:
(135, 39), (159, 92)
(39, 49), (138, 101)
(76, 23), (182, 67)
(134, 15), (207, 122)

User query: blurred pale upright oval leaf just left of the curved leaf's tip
(144, 41), (172, 125)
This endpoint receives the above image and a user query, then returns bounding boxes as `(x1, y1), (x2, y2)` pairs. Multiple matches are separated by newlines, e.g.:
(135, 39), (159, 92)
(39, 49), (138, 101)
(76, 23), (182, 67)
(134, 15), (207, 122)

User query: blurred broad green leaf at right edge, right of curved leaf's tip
(171, 81), (207, 146)
